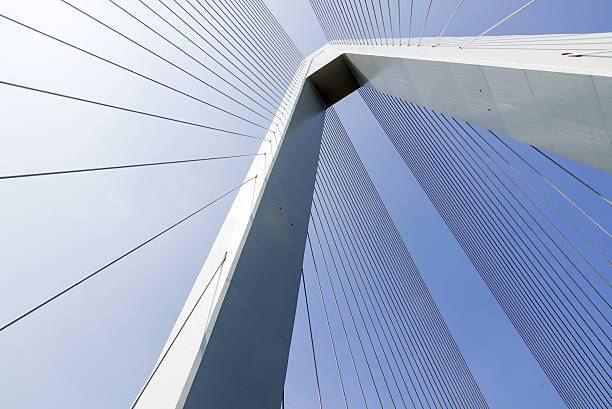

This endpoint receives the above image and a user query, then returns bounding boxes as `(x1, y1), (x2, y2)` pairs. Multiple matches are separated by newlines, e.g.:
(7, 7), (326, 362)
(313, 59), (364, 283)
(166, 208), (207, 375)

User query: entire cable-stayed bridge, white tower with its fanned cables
(0, 0), (612, 408)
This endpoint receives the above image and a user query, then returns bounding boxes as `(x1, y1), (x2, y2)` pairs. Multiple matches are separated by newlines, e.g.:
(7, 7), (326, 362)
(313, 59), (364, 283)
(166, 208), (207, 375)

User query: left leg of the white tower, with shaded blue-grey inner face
(135, 81), (325, 409)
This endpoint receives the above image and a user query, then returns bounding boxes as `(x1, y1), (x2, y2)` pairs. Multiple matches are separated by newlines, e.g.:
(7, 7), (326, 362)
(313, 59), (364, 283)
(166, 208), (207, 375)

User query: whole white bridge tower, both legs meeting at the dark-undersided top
(135, 33), (612, 409)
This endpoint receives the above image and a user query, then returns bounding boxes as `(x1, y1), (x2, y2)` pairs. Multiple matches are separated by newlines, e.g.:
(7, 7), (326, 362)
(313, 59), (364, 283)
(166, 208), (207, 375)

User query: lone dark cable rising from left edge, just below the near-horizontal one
(0, 175), (257, 332)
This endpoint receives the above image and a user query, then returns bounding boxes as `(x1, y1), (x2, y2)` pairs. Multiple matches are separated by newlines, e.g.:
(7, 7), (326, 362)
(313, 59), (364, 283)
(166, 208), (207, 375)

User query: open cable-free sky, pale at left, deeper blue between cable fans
(0, 0), (612, 408)
